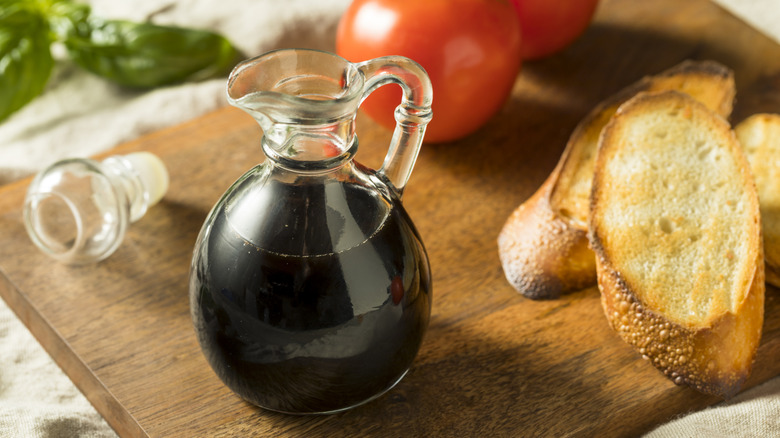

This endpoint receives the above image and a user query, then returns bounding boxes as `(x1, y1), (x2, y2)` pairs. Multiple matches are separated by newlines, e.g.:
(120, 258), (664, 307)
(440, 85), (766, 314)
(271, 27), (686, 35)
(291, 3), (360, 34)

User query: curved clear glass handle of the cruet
(357, 56), (433, 196)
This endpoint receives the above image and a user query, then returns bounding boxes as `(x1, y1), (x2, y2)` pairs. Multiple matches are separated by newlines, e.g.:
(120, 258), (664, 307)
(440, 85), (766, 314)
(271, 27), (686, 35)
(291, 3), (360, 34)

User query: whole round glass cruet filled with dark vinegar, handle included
(190, 49), (432, 413)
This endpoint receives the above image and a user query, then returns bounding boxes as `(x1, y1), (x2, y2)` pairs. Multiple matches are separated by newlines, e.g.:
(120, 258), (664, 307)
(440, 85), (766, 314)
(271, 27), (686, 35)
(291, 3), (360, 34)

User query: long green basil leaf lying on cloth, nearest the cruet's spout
(65, 18), (239, 88)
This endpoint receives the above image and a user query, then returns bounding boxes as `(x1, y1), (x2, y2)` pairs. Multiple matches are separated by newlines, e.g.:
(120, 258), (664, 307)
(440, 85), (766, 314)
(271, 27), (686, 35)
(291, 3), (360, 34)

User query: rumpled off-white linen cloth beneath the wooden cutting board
(0, 0), (780, 438)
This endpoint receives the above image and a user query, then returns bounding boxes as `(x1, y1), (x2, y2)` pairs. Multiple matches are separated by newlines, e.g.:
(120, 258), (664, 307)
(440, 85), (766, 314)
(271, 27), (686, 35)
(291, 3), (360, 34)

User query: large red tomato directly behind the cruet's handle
(336, 0), (521, 142)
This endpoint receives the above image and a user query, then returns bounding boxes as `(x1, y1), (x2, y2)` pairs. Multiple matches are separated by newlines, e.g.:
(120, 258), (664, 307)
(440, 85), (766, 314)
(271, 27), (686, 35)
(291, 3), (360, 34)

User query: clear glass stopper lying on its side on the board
(24, 152), (168, 264)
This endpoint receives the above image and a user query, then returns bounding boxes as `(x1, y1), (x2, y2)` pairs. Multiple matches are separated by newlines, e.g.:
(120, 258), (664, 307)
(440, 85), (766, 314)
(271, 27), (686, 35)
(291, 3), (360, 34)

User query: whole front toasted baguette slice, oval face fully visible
(589, 91), (765, 398)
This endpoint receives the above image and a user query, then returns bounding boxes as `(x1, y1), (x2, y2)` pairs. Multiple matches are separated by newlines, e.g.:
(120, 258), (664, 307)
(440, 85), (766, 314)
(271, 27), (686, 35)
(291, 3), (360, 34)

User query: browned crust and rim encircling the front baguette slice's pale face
(589, 91), (765, 398)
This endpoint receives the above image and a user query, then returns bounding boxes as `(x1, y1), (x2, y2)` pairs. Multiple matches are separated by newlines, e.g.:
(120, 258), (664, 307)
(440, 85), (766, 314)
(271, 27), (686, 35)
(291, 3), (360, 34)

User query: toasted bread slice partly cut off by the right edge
(734, 114), (780, 287)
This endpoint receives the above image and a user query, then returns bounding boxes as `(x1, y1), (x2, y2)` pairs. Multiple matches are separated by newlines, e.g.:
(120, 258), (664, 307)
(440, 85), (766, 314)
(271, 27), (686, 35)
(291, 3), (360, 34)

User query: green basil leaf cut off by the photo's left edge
(0, 2), (54, 120)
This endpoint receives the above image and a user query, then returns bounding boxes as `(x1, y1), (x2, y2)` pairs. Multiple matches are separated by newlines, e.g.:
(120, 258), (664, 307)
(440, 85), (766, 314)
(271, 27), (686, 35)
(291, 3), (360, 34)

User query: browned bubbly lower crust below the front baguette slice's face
(597, 250), (765, 399)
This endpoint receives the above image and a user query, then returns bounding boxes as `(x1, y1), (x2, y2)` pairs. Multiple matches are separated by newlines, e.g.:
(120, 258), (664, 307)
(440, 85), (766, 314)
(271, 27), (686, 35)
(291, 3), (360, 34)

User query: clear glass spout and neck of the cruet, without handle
(227, 49), (364, 163)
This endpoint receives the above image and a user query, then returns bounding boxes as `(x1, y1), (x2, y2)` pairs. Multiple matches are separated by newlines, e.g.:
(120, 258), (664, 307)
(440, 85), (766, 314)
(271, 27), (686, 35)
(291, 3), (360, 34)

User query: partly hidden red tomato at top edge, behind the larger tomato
(512, 0), (598, 59)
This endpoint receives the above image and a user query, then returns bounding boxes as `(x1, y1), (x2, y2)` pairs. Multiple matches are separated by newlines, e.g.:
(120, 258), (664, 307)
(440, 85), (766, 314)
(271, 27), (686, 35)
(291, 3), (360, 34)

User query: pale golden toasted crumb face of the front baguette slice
(600, 92), (757, 327)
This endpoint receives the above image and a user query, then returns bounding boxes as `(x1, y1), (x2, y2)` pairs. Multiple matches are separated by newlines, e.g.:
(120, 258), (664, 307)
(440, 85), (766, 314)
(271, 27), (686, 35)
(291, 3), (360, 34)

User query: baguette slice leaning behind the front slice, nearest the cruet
(498, 61), (736, 299)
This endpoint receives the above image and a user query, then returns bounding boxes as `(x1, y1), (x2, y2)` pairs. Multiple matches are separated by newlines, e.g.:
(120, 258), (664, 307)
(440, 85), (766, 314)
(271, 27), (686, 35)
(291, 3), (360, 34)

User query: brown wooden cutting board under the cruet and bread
(0, 0), (780, 437)
